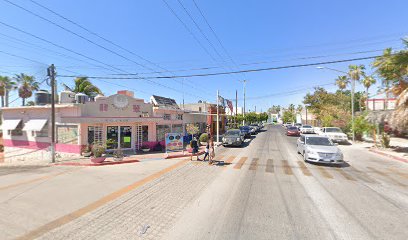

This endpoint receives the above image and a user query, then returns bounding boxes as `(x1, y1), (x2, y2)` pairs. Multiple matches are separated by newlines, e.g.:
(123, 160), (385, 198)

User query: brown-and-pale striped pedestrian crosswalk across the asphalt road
(209, 155), (408, 187)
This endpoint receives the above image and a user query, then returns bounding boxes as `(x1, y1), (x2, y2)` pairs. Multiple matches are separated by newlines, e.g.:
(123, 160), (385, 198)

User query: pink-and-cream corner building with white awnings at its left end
(1, 91), (184, 162)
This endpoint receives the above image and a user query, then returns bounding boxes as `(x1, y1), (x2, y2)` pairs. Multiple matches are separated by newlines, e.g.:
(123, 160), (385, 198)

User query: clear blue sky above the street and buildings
(0, 0), (408, 111)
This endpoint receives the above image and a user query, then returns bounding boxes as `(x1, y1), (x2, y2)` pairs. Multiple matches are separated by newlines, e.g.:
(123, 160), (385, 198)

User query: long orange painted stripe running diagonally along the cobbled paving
(17, 160), (190, 240)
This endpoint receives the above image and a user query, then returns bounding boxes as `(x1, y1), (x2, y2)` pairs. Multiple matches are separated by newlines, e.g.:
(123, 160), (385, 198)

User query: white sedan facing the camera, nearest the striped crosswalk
(296, 135), (344, 164)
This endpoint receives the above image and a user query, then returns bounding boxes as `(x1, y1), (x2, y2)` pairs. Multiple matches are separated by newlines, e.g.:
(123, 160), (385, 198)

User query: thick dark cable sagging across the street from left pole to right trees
(60, 55), (382, 79)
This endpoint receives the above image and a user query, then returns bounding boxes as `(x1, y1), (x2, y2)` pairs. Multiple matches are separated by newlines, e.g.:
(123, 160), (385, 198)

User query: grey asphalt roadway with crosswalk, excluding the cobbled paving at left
(163, 126), (408, 240)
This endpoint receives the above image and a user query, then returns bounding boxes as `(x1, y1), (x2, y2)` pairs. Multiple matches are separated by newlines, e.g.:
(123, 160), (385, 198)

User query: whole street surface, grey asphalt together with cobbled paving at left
(0, 126), (408, 239)
